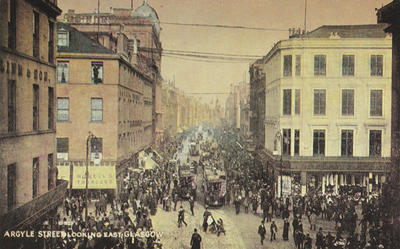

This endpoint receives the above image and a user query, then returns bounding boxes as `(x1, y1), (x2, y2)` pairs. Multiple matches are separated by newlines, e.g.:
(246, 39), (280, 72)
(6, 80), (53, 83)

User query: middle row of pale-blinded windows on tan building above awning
(57, 97), (103, 122)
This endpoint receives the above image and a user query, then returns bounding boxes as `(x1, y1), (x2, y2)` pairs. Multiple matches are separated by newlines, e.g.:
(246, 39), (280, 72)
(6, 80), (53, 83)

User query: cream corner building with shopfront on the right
(255, 25), (392, 194)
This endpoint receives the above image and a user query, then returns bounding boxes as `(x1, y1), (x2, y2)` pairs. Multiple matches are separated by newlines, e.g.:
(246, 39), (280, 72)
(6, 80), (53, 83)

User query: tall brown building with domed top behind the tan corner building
(64, 1), (162, 147)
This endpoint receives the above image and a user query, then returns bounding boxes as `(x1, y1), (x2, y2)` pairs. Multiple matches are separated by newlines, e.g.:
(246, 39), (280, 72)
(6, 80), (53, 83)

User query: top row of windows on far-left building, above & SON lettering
(6, 0), (55, 63)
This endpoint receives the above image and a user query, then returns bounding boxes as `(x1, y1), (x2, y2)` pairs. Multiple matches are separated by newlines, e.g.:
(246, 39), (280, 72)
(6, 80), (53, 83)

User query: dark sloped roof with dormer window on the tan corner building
(57, 22), (114, 54)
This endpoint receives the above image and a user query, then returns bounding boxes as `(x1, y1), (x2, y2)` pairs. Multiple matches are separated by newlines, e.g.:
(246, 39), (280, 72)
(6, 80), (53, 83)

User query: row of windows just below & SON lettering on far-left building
(7, 80), (54, 133)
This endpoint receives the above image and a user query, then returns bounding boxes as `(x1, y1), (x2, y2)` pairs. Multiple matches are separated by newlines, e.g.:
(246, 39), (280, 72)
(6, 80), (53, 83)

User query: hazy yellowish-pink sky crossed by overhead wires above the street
(58, 0), (391, 104)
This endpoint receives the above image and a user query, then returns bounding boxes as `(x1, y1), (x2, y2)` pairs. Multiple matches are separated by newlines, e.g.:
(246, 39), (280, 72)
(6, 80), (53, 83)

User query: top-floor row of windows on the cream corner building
(283, 55), (383, 77)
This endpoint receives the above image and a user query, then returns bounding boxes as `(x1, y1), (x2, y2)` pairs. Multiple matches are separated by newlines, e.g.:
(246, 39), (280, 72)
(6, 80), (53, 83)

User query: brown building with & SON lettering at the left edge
(0, 0), (66, 237)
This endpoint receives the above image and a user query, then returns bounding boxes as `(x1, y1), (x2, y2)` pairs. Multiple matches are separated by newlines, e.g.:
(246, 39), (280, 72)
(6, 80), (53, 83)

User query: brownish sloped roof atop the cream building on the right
(301, 24), (387, 38)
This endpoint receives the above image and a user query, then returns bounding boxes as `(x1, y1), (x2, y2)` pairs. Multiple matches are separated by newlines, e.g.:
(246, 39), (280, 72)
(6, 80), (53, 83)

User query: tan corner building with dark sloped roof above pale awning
(57, 23), (152, 189)
